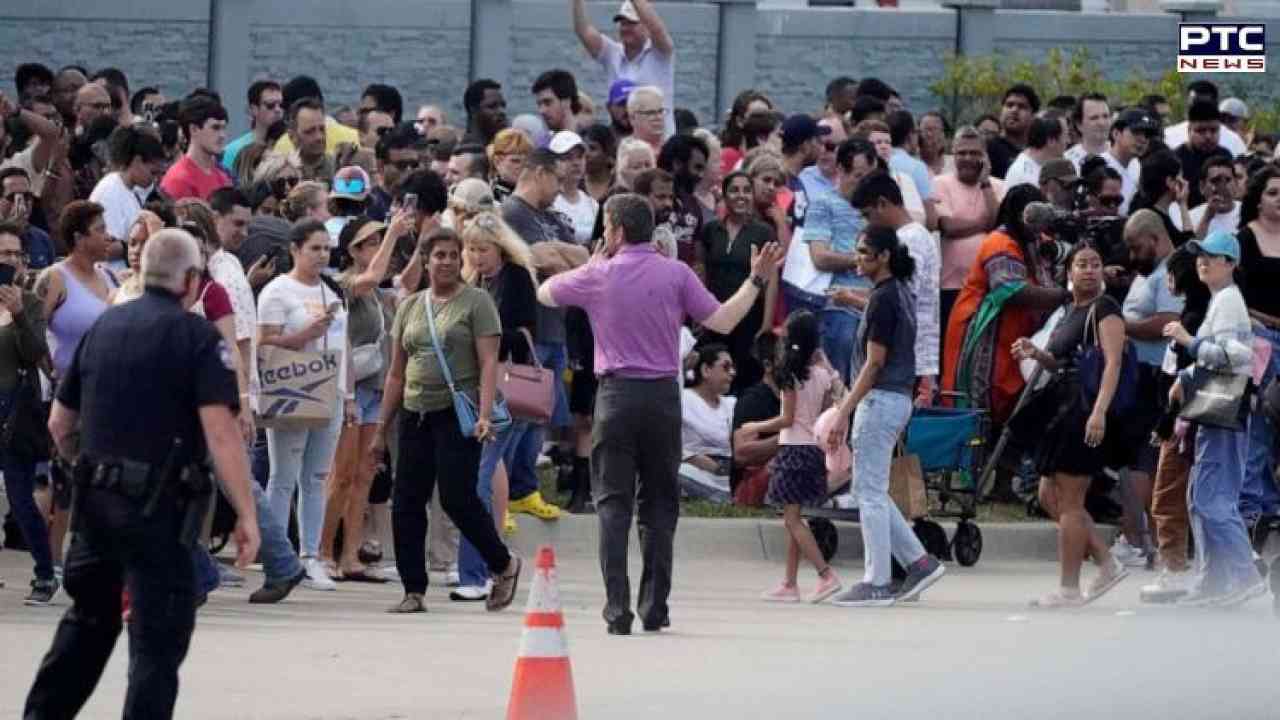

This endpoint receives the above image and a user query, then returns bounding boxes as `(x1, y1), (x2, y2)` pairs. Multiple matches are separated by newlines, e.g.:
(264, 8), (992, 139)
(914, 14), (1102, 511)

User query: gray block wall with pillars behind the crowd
(0, 0), (1280, 129)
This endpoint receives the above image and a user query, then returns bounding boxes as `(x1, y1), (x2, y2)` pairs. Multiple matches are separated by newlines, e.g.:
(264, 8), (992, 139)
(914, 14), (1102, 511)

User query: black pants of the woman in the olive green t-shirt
(392, 407), (511, 593)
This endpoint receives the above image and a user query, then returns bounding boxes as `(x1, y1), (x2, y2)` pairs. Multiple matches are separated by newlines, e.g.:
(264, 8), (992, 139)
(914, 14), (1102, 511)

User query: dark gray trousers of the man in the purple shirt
(591, 377), (681, 625)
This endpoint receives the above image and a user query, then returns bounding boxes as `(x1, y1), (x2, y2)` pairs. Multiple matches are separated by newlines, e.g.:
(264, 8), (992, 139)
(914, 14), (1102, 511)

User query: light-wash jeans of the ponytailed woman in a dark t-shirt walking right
(852, 389), (924, 587)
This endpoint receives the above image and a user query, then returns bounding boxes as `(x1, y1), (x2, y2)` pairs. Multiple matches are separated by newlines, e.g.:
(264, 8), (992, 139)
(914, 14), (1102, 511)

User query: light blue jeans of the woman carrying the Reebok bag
(266, 397), (342, 557)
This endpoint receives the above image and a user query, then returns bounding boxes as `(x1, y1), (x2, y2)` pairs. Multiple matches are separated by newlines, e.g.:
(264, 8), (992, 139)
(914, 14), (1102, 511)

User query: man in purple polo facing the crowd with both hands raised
(538, 193), (782, 635)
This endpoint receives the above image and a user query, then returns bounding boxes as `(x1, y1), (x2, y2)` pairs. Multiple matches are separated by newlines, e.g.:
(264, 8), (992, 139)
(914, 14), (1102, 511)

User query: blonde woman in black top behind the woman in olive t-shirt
(449, 210), (538, 602)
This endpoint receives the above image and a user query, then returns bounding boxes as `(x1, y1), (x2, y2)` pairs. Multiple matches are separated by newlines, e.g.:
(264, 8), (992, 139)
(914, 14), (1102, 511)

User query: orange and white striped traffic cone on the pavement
(507, 544), (577, 720)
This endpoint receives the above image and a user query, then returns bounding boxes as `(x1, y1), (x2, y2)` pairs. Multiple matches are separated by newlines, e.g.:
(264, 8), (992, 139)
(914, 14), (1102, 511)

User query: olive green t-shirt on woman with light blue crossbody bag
(392, 286), (502, 413)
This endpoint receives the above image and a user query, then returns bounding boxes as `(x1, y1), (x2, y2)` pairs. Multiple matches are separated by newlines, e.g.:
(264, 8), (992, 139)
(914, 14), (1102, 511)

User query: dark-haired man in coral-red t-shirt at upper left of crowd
(160, 95), (232, 202)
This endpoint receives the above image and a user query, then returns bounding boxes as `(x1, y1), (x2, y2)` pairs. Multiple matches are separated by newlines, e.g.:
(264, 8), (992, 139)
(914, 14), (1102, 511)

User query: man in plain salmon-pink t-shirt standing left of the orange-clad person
(933, 127), (1005, 328)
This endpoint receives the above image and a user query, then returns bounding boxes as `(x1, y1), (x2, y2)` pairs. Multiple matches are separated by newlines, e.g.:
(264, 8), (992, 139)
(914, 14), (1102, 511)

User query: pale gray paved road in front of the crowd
(0, 552), (1280, 720)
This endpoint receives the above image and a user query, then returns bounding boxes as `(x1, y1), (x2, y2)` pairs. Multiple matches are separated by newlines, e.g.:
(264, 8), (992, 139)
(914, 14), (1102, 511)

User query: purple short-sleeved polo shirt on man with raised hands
(550, 242), (719, 379)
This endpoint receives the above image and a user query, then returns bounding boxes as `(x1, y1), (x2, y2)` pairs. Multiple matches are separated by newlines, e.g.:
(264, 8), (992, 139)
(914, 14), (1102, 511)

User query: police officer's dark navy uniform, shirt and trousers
(23, 288), (239, 720)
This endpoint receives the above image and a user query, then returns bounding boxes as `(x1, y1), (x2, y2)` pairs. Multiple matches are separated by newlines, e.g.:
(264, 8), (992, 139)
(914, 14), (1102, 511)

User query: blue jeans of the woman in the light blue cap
(1189, 417), (1258, 593)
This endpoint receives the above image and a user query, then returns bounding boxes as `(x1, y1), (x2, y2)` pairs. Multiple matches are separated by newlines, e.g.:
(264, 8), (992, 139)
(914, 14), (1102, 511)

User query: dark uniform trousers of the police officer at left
(23, 489), (196, 720)
